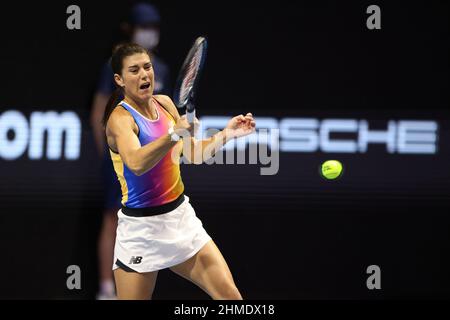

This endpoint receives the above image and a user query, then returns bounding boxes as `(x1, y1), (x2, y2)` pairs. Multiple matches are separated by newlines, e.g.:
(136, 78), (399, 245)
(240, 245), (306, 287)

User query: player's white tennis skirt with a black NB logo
(113, 196), (211, 273)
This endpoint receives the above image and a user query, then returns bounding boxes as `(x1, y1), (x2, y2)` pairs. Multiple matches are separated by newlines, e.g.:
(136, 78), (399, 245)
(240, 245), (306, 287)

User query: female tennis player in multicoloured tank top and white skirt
(103, 44), (255, 300)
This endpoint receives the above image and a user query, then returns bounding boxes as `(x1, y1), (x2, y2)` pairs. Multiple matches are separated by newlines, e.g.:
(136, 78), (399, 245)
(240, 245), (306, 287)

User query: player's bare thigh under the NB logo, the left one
(114, 268), (158, 300)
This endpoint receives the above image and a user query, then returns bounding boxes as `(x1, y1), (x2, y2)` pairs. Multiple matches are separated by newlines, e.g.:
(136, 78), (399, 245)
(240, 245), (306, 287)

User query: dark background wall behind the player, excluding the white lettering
(0, 1), (450, 299)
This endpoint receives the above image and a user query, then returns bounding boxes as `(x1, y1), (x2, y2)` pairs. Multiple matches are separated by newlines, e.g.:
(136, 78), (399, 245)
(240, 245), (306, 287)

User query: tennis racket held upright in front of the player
(173, 37), (207, 123)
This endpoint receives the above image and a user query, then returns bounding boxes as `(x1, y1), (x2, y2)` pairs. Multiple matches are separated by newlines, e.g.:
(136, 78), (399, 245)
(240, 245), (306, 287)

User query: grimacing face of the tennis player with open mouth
(121, 53), (155, 101)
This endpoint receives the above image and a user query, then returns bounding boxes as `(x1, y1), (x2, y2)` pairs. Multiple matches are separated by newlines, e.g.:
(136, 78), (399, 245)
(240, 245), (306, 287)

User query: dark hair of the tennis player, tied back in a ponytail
(102, 43), (150, 128)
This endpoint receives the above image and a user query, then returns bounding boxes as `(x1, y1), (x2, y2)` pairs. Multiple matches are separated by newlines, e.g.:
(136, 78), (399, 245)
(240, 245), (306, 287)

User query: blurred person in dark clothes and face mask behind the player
(90, 2), (170, 300)
